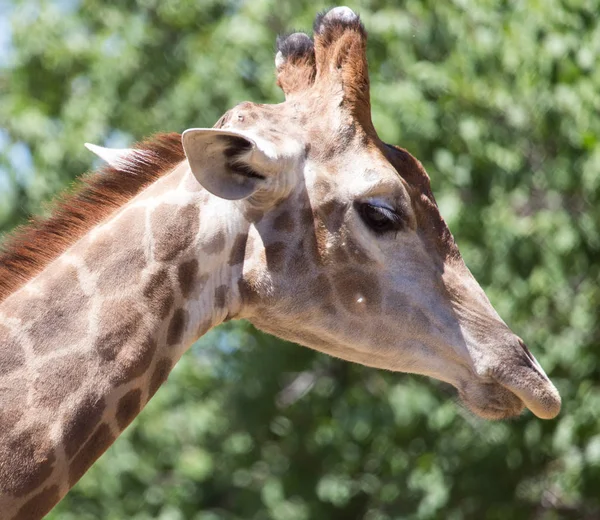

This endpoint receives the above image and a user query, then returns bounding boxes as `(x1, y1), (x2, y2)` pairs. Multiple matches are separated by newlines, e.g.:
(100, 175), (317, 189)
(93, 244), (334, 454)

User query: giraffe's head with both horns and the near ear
(103, 7), (560, 419)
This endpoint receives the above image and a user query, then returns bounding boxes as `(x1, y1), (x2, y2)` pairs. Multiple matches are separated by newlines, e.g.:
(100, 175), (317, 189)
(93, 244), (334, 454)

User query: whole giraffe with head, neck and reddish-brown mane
(0, 7), (560, 520)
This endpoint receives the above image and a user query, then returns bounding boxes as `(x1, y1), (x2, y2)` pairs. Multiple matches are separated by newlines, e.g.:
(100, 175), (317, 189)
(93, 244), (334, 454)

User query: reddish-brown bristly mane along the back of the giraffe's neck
(0, 133), (185, 302)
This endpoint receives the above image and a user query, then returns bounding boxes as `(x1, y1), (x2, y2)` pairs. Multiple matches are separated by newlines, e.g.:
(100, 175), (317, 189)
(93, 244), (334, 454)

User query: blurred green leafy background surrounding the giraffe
(0, 0), (600, 520)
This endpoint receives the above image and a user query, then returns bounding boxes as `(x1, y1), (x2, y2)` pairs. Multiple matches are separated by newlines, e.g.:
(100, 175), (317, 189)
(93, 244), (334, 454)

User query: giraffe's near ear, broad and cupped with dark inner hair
(181, 128), (265, 200)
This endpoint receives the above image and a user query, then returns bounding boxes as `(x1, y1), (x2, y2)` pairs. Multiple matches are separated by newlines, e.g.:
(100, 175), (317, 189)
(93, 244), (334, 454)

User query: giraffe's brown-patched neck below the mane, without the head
(0, 163), (249, 518)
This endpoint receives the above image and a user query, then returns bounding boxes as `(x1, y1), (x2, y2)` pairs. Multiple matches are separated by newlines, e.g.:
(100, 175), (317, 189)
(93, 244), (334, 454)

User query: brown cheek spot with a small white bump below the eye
(333, 269), (381, 312)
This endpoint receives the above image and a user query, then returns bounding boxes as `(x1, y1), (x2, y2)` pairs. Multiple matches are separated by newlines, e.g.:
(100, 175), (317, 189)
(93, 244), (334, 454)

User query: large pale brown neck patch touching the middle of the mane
(85, 208), (147, 294)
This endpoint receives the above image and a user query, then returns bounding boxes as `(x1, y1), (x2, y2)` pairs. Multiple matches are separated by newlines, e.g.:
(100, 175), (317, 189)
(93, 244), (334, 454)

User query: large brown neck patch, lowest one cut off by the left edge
(0, 423), (56, 497)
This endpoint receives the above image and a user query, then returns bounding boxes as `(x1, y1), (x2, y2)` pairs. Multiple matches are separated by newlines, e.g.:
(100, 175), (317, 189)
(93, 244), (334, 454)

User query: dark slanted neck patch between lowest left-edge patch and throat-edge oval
(62, 393), (106, 459)
